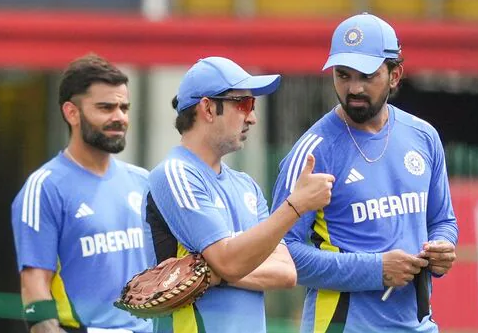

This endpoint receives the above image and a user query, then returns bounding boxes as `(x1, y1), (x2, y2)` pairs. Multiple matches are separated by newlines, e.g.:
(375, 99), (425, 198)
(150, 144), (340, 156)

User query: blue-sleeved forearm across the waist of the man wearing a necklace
(288, 241), (383, 292)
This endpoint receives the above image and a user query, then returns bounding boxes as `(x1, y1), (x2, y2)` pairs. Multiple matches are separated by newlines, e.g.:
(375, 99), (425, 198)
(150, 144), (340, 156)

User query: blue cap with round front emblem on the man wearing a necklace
(322, 13), (400, 74)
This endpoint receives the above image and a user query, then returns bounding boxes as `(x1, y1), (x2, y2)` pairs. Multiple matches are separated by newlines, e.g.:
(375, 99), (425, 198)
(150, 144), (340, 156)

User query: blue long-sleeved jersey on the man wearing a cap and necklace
(273, 105), (457, 333)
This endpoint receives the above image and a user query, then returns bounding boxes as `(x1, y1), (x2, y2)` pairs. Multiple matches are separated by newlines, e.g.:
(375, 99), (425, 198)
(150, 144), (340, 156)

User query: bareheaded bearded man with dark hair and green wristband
(12, 55), (154, 333)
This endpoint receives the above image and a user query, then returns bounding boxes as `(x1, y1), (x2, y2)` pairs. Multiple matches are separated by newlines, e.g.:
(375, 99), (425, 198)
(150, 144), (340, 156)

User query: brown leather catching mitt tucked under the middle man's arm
(114, 254), (211, 318)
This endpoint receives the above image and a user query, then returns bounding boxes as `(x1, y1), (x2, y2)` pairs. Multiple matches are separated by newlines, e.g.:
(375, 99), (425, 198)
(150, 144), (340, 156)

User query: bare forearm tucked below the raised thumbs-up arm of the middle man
(230, 245), (297, 291)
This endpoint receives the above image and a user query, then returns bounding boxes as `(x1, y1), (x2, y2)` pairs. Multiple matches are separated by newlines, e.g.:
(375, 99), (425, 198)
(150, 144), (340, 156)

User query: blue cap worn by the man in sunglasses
(177, 57), (281, 113)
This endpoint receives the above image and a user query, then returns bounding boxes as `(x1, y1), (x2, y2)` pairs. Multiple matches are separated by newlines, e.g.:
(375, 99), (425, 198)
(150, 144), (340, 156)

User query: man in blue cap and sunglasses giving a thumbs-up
(144, 57), (334, 333)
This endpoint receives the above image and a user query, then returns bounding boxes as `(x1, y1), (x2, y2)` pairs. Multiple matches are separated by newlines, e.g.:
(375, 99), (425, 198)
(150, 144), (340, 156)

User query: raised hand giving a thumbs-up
(289, 155), (335, 215)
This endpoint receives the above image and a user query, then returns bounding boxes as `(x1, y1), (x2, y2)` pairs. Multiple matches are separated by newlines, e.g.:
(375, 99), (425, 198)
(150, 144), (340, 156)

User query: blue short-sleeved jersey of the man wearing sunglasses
(149, 147), (269, 333)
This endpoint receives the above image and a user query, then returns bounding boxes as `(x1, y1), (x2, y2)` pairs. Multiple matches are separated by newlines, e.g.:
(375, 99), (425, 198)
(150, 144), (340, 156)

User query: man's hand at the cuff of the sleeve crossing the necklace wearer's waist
(382, 250), (428, 287)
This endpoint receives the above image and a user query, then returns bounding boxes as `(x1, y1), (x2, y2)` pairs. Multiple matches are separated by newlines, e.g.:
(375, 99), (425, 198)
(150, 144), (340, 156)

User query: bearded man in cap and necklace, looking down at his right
(272, 13), (457, 333)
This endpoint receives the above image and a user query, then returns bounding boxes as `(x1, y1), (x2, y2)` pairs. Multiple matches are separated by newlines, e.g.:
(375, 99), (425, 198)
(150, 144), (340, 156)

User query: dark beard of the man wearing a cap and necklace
(336, 90), (390, 124)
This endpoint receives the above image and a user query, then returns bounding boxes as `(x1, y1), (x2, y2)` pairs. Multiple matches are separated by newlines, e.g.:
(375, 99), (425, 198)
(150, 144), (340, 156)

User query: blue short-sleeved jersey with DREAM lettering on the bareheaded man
(12, 153), (154, 332)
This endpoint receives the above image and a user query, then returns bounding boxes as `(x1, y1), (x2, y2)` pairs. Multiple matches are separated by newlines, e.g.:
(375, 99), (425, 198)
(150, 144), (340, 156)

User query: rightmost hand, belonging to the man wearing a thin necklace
(418, 240), (456, 275)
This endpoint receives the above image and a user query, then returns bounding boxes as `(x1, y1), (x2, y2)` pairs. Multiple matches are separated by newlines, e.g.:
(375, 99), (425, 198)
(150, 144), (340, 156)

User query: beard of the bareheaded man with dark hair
(80, 110), (127, 154)
